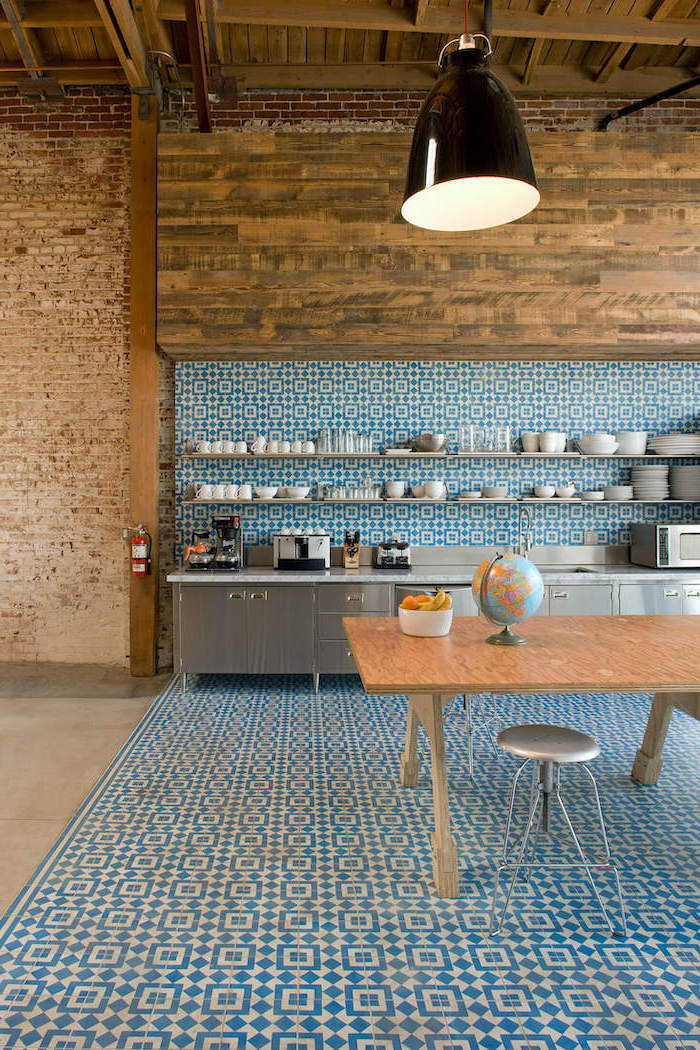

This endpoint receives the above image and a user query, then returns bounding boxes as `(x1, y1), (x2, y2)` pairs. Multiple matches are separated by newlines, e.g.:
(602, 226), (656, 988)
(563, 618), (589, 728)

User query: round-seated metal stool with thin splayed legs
(489, 726), (628, 937)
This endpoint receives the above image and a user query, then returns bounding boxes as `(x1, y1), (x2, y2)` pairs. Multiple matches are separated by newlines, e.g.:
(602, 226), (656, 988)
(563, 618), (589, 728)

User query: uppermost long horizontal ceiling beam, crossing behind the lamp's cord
(158, 0), (700, 47)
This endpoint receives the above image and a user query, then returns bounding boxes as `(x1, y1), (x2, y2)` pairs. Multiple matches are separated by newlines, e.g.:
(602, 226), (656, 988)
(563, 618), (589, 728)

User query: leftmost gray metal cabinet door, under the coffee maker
(175, 584), (248, 674)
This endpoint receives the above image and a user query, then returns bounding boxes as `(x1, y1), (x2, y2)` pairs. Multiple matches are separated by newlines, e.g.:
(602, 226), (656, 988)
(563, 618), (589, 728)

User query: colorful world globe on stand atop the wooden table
(471, 554), (545, 646)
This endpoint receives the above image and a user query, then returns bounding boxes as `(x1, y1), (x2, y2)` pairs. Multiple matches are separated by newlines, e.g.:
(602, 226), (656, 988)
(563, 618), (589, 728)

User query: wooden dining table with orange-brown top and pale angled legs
(343, 616), (700, 898)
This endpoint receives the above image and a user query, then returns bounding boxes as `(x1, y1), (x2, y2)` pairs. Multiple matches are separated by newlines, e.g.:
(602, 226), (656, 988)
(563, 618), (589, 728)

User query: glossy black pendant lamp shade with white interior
(401, 46), (539, 230)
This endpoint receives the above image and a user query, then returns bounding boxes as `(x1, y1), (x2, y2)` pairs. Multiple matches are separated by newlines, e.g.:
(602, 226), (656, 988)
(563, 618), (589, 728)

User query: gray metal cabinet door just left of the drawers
(247, 584), (314, 674)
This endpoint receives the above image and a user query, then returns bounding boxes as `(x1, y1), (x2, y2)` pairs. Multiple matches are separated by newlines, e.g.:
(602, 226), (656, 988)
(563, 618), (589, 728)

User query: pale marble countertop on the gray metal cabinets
(168, 565), (700, 587)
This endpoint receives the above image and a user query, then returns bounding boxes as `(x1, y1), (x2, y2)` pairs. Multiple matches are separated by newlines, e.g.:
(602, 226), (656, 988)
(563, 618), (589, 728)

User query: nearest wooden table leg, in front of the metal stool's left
(410, 695), (460, 898)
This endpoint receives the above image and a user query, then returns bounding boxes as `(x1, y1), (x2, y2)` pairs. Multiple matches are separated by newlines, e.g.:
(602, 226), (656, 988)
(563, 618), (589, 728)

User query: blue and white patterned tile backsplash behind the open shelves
(175, 361), (700, 557)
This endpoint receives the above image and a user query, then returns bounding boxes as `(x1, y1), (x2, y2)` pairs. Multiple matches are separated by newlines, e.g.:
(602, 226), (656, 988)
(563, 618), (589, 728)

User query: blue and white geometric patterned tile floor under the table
(0, 676), (700, 1050)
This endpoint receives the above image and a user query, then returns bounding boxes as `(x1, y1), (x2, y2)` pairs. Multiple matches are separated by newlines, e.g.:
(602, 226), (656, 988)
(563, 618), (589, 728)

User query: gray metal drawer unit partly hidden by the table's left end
(317, 584), (394, 674)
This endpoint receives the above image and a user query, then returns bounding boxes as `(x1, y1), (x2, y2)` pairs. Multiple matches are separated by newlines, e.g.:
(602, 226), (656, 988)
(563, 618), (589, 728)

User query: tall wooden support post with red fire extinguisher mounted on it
(129, 96), (160, 676)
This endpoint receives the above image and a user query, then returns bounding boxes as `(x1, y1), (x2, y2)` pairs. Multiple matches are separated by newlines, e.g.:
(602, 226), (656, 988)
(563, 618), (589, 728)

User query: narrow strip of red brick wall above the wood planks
(158, 91), (700, 131)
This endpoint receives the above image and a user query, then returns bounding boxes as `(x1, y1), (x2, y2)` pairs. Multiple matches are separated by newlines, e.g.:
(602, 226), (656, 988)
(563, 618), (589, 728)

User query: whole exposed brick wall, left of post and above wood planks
(0, 88), (700, 667)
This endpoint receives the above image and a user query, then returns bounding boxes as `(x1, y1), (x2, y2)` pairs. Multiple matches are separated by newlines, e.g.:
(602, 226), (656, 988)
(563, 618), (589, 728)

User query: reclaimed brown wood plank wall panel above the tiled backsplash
(158, 131), (700, 359)
